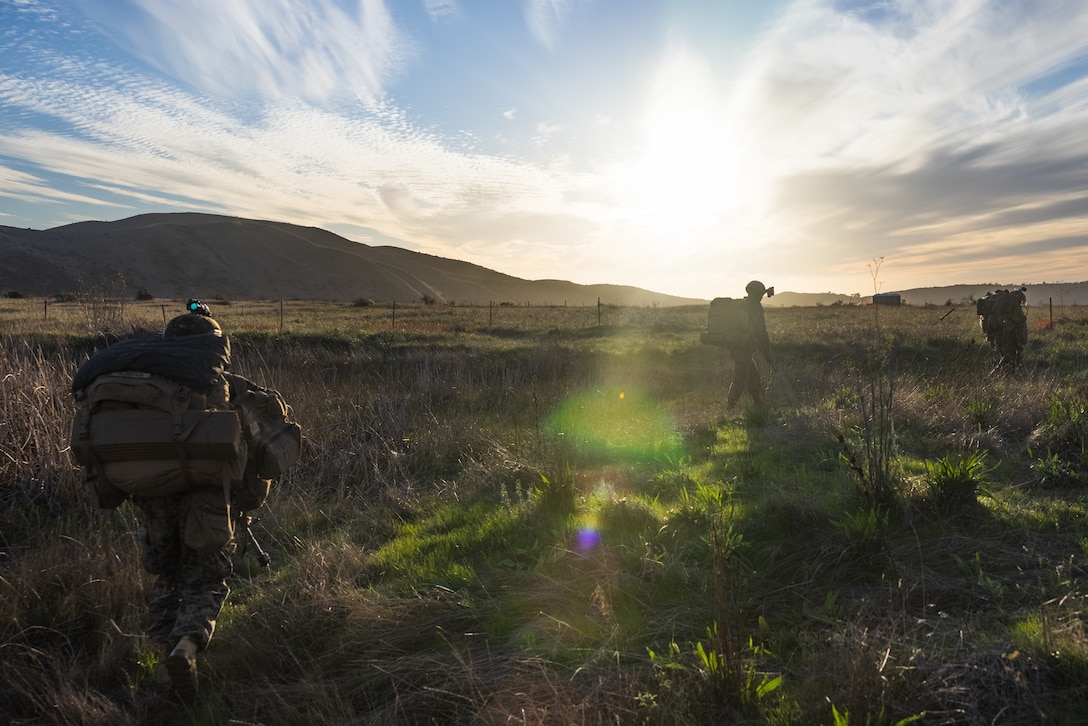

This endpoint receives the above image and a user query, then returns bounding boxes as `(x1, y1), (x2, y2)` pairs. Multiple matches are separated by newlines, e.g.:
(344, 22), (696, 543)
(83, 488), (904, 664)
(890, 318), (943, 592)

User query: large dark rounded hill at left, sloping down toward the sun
(0, 212), (704, 307)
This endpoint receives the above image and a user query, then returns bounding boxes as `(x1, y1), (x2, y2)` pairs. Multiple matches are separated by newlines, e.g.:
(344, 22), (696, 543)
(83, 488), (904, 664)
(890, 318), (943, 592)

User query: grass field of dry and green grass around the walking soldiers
(0, 299), (1088, 726)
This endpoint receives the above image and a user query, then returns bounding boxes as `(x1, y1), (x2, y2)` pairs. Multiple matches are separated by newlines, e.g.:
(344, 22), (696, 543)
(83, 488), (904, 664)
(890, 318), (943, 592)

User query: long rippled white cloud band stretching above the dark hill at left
(0, 53), (587, 254)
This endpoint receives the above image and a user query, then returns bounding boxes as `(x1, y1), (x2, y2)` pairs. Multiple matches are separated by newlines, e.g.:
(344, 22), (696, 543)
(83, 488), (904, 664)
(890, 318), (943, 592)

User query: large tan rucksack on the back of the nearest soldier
(71, 334), (246, 507)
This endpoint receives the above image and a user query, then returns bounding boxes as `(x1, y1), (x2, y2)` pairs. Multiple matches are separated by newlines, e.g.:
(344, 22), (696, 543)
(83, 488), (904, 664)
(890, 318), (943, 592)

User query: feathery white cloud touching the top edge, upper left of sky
(84, 0), (409, 103)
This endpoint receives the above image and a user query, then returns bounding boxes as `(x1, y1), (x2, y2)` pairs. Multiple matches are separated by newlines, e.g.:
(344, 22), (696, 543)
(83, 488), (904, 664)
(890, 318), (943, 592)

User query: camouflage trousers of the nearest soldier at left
(136, 494), (232, 650)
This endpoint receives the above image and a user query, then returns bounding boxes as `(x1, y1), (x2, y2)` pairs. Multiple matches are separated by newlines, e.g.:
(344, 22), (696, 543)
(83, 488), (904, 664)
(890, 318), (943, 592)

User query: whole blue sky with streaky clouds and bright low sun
(0, 0), (1088, 297)
